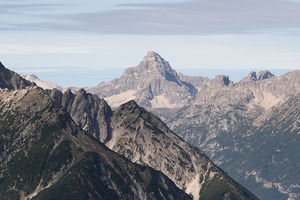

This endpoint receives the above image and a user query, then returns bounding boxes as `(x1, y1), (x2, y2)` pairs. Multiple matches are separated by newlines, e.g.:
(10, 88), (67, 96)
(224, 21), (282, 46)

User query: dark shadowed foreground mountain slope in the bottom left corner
(0, 86), (190, 200)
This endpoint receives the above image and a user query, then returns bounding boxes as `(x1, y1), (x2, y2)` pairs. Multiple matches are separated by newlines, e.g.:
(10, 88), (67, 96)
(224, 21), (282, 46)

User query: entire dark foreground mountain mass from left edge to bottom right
(0, 61), (257, 199)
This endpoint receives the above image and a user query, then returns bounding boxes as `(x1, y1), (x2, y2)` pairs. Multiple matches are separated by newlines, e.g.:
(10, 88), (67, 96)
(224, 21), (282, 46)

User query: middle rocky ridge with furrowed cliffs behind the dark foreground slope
(47, 89), (256, 199)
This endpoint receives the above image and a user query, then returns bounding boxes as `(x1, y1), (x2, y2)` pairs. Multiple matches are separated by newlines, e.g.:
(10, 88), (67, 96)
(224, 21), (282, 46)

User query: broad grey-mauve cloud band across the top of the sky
(2, 0), (300, 35)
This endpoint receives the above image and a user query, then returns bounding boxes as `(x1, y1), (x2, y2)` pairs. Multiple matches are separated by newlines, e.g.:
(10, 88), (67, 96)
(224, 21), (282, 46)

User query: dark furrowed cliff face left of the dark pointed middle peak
(47, 89), (112, 143)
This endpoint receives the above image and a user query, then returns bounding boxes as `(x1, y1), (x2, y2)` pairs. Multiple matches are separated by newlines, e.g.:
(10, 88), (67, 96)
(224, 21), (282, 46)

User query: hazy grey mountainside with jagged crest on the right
(167, 71), (300, 199)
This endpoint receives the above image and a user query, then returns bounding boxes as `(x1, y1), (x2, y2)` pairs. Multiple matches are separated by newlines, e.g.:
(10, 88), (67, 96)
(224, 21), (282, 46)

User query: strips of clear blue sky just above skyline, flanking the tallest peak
(12, 67), (296, 88)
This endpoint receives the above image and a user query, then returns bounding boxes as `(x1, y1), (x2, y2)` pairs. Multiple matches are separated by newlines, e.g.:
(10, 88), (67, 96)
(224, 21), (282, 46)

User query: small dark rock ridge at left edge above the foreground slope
(0, 62), (35, 90)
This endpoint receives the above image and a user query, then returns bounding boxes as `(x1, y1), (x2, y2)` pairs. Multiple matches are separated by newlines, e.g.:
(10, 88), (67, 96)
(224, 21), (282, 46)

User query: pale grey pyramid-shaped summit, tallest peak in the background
(87, 51), (207, 118)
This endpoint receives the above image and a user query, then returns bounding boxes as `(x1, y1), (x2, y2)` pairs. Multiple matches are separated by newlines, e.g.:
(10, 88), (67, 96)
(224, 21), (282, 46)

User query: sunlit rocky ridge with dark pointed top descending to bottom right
(106, 100), (256, 199)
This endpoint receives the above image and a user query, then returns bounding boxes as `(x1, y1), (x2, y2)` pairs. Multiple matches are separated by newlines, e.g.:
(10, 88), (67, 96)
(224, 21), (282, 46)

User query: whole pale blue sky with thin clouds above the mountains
(0, 0), (300, 86)
